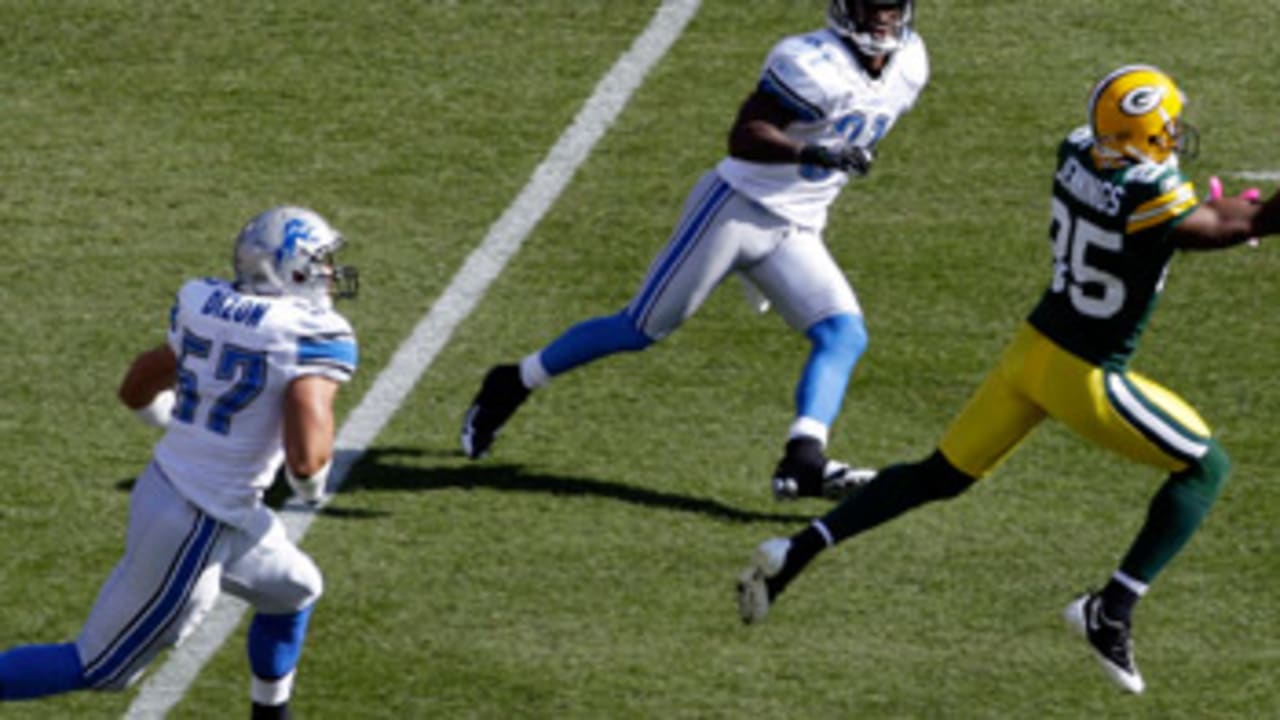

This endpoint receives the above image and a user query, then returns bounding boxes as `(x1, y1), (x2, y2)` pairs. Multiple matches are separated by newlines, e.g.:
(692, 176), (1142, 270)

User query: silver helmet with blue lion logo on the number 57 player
(232, 205), (360, 307)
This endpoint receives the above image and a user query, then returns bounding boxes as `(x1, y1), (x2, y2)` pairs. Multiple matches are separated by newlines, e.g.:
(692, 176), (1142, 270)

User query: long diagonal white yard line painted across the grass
(124, 0), (700, 720)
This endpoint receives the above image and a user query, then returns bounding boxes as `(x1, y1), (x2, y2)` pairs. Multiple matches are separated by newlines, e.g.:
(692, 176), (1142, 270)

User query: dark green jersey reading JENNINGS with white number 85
(1028, 127), (1198, 368)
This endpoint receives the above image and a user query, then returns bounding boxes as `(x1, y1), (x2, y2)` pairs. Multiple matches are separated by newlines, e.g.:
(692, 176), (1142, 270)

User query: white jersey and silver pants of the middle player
(622, 29), (928, 338)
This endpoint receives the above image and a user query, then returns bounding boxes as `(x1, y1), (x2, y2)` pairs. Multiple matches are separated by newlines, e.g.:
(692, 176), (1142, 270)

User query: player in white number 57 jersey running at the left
(0, 206), (357, 719)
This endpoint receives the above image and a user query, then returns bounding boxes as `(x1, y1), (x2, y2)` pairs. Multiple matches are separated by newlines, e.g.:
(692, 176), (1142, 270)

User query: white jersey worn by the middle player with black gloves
(717, 29), (929, 232)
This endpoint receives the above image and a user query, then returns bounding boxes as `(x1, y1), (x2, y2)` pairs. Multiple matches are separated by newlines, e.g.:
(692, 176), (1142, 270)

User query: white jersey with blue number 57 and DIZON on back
(155, 274), (357, 527)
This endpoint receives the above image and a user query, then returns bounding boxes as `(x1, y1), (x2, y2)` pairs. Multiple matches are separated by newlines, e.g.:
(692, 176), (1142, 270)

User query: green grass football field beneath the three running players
(0, 0), (1280, 719)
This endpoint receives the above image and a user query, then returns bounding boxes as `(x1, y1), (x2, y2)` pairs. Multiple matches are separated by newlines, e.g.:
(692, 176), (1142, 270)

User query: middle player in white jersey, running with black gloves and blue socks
(461, 0), (929, 500)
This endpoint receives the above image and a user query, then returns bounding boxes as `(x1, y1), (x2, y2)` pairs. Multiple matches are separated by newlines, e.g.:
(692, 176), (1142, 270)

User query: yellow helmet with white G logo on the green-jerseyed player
(1089, 65), (1199, 164)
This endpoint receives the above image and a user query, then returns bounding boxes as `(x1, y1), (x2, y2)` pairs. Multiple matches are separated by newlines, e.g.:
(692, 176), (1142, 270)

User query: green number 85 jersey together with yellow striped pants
(940, 127), (1211, 477)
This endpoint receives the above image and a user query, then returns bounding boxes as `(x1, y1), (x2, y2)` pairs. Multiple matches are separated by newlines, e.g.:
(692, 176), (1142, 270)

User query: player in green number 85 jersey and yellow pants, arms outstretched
(737, 65), (1280, 693)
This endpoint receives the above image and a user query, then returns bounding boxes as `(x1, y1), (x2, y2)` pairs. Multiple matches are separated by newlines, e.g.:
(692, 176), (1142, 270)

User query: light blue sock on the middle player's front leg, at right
(796, 315), (867, 427)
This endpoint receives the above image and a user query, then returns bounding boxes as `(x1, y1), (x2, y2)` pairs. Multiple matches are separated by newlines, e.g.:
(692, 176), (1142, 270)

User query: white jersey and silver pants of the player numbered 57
(76, 279), (357, 689)
